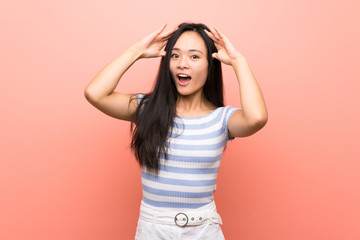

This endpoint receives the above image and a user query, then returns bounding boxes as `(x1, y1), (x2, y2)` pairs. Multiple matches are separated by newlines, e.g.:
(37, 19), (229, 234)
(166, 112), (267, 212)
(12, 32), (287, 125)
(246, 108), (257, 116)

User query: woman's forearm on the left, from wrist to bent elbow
(85, 45), (141, 101)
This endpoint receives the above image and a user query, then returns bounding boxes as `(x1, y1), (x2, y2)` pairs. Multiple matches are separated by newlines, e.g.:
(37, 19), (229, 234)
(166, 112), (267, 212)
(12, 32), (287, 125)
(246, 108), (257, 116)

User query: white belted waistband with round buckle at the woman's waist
(139, 201), (222, 227)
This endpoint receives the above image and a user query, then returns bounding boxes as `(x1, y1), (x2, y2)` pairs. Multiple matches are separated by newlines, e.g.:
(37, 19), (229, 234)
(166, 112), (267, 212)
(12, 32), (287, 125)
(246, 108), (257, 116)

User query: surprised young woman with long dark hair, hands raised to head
(85, 23), (267, 240)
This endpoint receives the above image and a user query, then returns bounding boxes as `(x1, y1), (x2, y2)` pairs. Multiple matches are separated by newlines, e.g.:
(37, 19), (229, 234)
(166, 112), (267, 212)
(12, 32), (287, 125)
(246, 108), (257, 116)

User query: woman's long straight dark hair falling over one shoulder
(131, 23), (224, 172)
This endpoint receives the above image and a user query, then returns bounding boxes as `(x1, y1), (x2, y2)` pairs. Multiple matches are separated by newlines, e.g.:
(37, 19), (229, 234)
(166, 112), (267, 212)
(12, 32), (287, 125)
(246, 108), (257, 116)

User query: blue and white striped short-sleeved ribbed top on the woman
(138, 95), (238, 210)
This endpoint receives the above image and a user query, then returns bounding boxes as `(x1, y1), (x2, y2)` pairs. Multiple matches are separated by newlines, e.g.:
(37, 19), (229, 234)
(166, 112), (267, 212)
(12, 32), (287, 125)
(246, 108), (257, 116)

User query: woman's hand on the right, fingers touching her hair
(205, 27), (243, 66)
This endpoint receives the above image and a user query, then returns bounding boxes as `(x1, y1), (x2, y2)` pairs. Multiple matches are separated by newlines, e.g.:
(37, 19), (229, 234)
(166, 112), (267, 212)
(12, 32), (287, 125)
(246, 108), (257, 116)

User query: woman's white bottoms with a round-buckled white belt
(135, 201), (225, 240)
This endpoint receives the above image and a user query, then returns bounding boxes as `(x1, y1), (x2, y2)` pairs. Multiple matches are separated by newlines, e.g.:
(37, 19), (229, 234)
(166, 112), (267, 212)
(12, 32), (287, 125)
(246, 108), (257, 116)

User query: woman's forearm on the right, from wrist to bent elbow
(232, 56), (267, 124)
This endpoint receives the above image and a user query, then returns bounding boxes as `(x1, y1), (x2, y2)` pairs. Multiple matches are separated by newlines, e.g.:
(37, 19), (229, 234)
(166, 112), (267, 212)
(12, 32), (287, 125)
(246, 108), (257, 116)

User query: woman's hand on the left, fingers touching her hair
(135, 24), (177, 58)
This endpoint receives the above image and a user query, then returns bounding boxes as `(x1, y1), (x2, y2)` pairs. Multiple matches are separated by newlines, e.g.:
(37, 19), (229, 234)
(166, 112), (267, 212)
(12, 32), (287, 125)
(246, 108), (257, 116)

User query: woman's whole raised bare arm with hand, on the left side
(84, 25), (174, 121)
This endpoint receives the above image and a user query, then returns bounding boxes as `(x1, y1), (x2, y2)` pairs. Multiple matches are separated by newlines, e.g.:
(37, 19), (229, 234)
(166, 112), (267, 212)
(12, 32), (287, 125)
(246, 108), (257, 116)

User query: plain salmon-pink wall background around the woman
(0, 0), (360, 240)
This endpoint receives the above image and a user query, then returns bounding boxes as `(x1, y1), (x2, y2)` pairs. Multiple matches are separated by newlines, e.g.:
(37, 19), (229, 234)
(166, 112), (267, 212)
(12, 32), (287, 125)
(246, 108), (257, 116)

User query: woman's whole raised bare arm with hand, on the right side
(207, 28), (268, 138)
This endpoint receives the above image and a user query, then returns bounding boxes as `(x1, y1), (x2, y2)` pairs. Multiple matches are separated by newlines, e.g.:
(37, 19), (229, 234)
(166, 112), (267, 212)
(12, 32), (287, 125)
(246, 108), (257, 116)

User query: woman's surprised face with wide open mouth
(170, 31), (209, 96)
